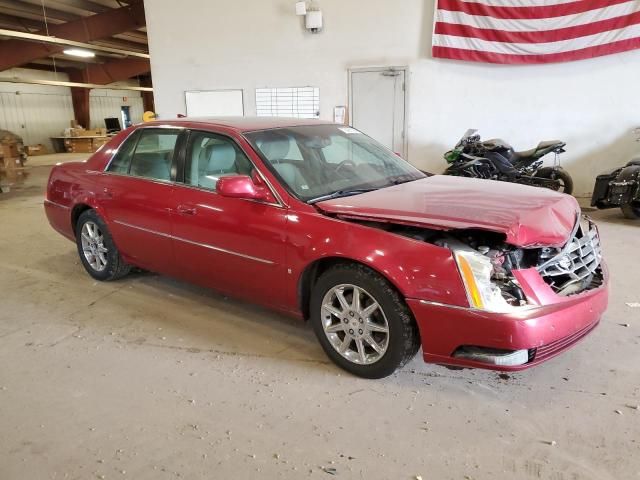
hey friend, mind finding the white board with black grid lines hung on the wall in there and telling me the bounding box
[255,85,320,119]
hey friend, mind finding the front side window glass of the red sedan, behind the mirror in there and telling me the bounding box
[185,132,253,190]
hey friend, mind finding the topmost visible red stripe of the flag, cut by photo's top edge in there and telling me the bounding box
[438,0,635,20]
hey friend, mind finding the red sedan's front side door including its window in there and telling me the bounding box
[173,131,287,307]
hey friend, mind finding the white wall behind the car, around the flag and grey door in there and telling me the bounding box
[145,0,640,196]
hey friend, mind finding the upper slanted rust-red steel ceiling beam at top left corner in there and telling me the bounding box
[0,2,145,71]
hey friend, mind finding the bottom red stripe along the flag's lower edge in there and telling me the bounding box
[433,38,640,64]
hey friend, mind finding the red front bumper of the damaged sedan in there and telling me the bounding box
[407,263,609,371]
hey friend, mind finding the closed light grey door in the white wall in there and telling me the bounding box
[351,68,406,158]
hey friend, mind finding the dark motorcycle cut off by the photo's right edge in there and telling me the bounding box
[591,128,640,219]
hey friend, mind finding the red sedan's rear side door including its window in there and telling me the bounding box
[96,128,183,273]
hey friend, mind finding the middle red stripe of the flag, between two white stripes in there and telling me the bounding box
[435,12,640,43]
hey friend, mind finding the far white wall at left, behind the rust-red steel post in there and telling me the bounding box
[0,68,143,148]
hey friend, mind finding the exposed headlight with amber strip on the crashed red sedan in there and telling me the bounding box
[453,250,516,312]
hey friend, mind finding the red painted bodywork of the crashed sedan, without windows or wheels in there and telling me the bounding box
[45,118,608,370]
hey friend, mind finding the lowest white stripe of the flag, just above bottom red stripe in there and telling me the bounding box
[434,25,640,55]
